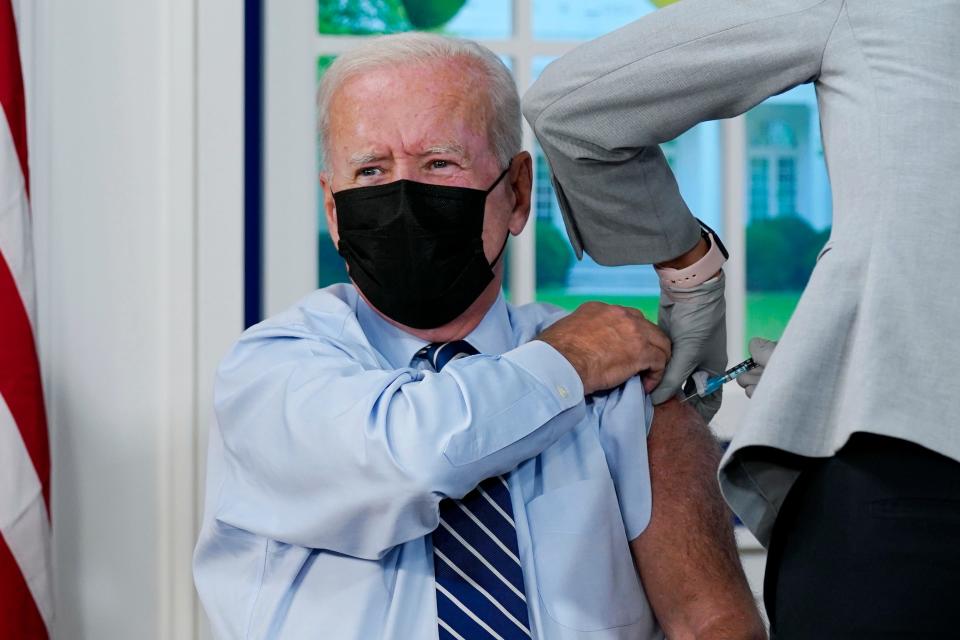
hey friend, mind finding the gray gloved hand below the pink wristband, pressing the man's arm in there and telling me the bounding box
[650,272,727,422]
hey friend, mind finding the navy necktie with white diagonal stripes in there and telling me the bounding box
[418,340,531,640]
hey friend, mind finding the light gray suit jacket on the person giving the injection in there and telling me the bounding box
[524,0,960,543]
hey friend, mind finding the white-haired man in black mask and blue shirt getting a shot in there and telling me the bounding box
[195,35,764,640]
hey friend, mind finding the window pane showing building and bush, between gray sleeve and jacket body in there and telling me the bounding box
[744,85,832,351]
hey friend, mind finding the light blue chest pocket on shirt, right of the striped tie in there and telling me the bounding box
[527,478,648,631]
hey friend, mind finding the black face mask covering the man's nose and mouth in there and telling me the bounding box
[333,164,510,329]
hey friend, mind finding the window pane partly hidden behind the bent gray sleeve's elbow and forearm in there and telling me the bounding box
[533,57,723,319]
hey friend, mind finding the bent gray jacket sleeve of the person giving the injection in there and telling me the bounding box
[523,0,843,265]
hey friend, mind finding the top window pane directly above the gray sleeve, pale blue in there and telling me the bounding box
[533,0,667,40]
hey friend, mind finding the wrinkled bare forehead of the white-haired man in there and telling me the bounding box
[326,60,492,156]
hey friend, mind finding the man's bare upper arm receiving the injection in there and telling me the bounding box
[630,400,766,639]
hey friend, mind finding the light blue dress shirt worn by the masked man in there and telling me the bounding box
[194,285,662,640]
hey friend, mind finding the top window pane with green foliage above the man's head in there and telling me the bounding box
[317,0,512,38]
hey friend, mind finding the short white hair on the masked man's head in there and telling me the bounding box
[317,32,523,166]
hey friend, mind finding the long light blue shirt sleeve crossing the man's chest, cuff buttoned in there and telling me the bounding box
[214,326,584,559]
